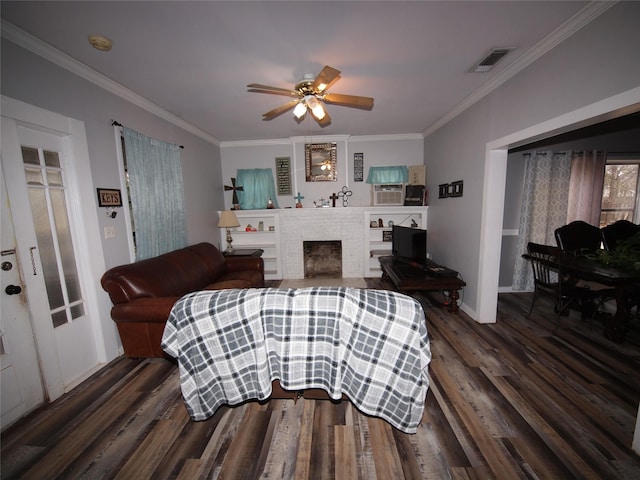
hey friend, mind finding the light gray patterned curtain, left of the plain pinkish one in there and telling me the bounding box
[513,151,571,291]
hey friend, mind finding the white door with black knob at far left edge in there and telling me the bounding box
[0,169,44,430]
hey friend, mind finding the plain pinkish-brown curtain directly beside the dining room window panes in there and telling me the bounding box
[567,150,606,227]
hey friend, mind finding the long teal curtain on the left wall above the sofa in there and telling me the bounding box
[122,127,187,260]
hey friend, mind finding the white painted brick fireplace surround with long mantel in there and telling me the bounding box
[221,206,428,279]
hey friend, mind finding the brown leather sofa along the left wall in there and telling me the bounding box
[101,243,264,358]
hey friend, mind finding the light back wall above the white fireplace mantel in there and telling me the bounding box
[221,134,424,208]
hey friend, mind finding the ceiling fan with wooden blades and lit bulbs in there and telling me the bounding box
[247,65,373,127]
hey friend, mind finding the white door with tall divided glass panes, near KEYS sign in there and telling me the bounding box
[2,117,98,400]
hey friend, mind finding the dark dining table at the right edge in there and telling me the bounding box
[557,253,640,343]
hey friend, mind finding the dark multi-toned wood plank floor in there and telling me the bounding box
[1,281,640,480]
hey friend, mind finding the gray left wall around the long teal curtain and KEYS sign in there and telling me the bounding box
[1,38,223,268]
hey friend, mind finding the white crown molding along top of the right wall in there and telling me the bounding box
[422,0,618,137]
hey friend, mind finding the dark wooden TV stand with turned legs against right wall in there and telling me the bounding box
[379,257,467,313]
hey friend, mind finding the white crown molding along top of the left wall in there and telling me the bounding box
[0,19,220,145]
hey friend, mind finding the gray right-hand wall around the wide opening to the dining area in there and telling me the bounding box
[425,2,640,322]
